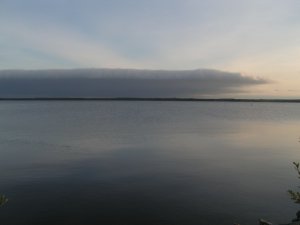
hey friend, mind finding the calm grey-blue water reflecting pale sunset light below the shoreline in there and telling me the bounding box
[0,101,300,225]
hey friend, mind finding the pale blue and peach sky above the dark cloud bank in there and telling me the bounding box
[0,0,300,98]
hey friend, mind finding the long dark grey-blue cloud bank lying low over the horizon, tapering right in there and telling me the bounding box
[0,69,268,98]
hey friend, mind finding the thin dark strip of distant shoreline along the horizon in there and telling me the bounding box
[0,97,300,103]
